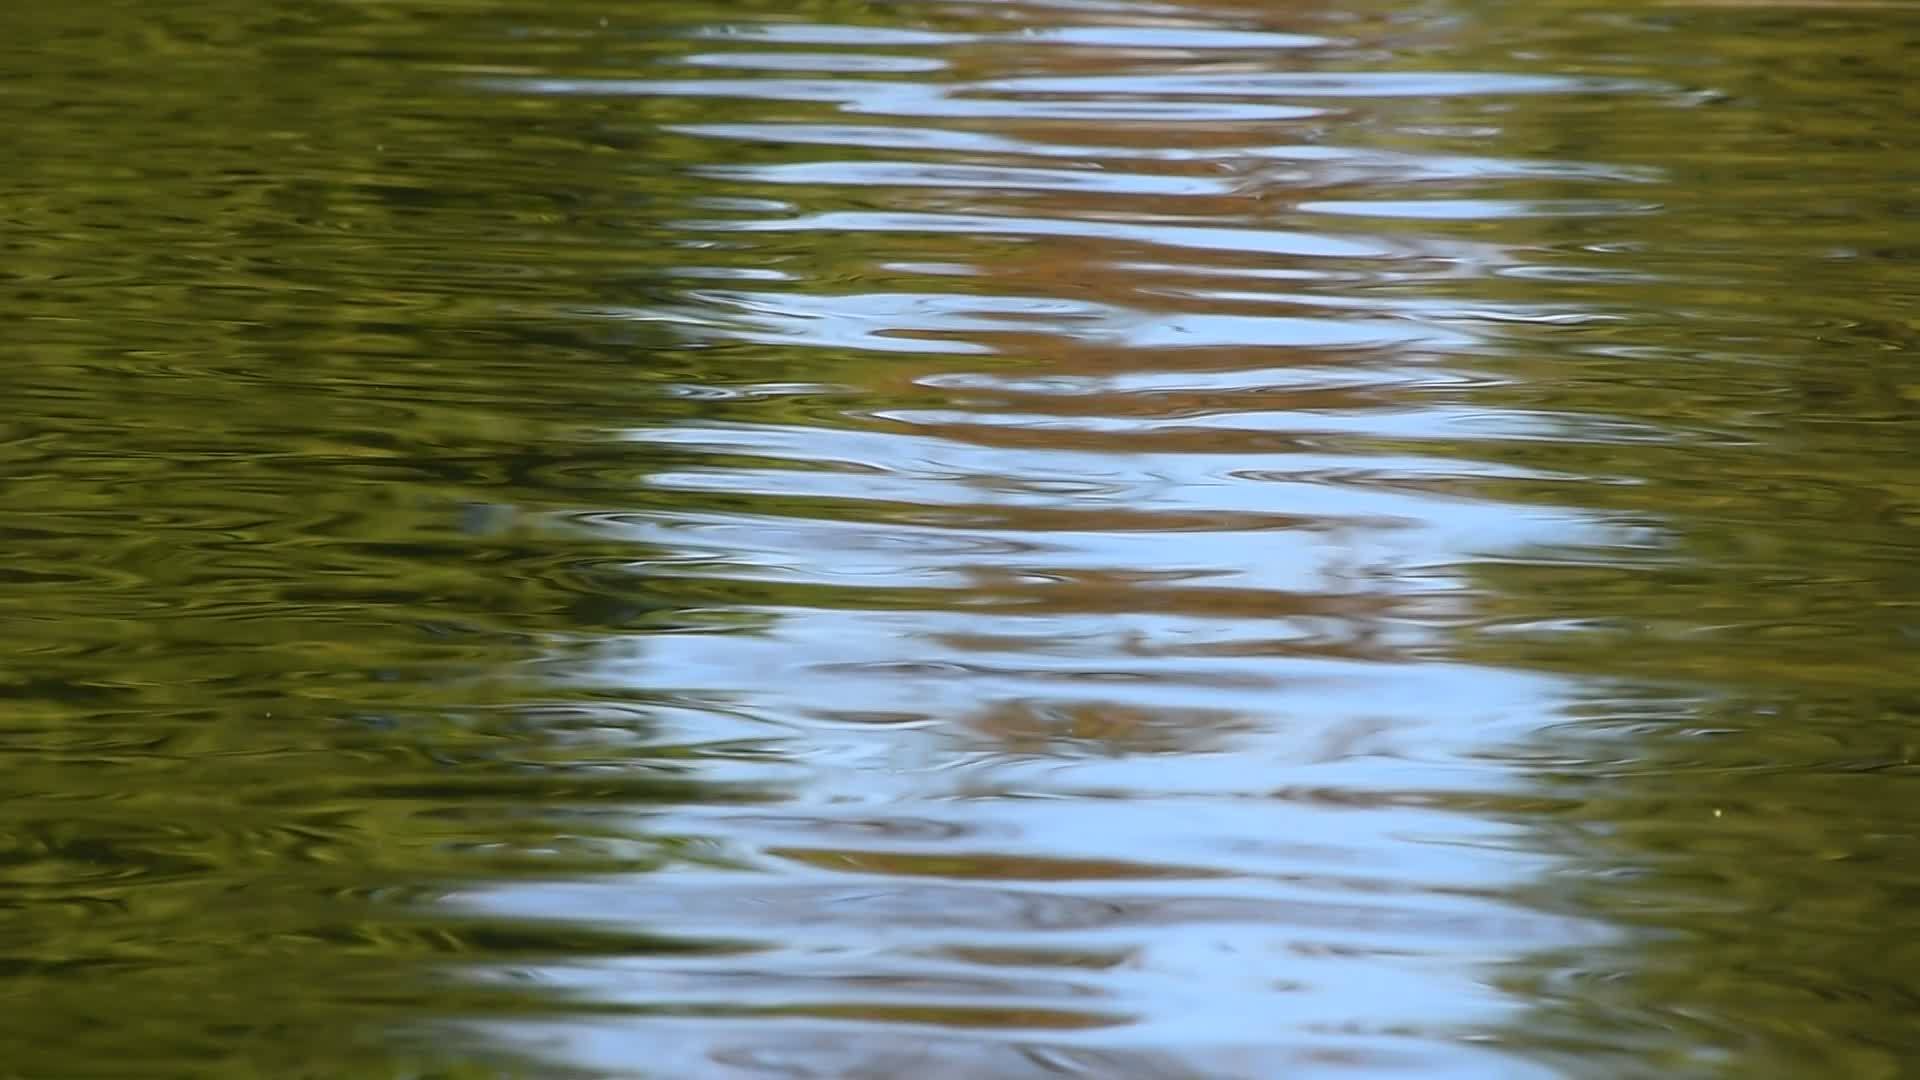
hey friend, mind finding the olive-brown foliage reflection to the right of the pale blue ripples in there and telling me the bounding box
[1390,6,1920,1076]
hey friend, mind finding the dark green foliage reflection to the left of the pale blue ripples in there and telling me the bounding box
[0,0,802,1076]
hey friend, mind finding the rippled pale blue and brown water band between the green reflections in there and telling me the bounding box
[459,6,1655,1076]
